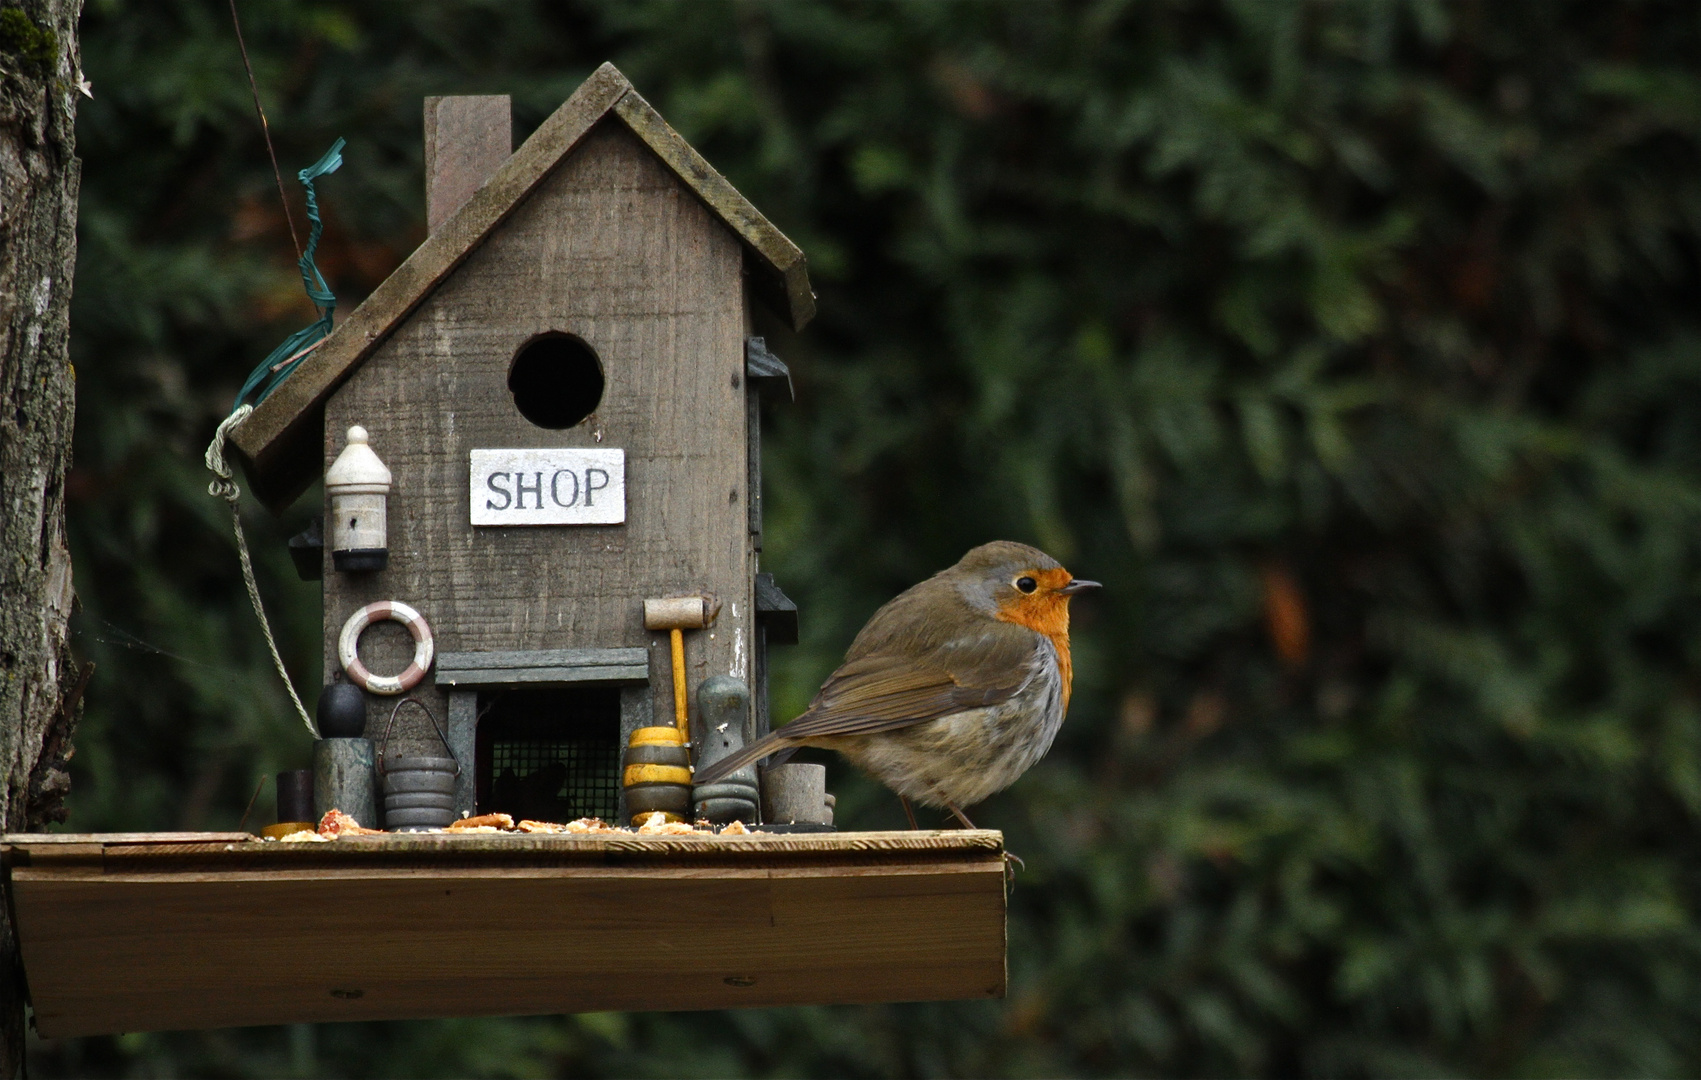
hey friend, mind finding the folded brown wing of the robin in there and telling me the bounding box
[777,619,1044,742]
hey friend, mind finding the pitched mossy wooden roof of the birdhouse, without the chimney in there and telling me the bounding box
[231,63,815,512]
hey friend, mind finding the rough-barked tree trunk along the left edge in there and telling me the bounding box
[0,0,83,1078]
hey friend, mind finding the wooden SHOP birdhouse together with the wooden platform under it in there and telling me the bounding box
[5,65,1005,1036]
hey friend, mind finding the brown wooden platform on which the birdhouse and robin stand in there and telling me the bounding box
[0,830,1005,1037]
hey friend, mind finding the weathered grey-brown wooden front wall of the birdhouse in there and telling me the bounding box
[323,121,754,742]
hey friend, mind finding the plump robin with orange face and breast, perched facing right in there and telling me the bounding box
[696,541,1099,828]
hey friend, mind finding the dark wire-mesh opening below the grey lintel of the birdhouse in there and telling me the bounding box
[478,687,621,821]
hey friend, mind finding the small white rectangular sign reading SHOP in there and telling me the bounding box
[471,447,626,526]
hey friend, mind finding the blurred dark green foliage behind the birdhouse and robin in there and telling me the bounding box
[31,0,1701,1077]
